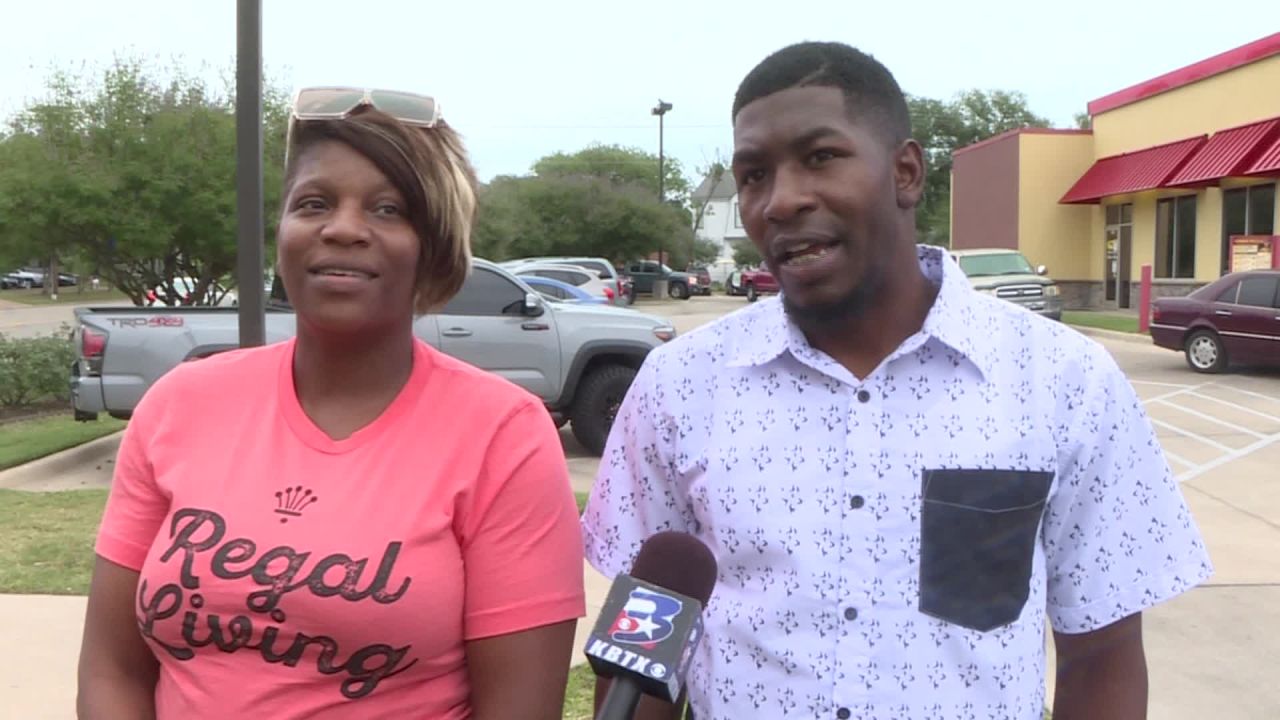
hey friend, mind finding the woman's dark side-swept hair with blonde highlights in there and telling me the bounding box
[284,106,477,314]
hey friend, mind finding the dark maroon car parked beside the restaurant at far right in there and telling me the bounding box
[1151,270,1280,373]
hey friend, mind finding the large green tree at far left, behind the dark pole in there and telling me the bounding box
[0,60,287,304]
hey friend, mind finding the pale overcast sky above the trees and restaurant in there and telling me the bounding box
[0,0,1280,182]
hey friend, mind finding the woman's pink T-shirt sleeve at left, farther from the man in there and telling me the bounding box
[95,382,170,570]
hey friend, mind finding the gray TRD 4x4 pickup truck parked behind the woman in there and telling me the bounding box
[70,260,676,455]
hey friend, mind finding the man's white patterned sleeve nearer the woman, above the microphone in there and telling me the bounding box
[582,351,694,578]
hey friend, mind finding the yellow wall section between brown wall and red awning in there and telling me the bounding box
[1018,133,1093,281]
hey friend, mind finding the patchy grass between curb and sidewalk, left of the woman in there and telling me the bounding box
[0,489,106,594]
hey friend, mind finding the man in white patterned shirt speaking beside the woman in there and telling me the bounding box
[584,44,1211,720]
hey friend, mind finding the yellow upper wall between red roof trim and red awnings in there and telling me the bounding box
[1093,55,1280,157]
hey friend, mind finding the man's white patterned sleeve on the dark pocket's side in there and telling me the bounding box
[1044,348,1212,633]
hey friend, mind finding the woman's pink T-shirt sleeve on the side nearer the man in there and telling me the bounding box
[457,401,586,641]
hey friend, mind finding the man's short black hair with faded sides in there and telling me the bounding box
[732,42,911,145]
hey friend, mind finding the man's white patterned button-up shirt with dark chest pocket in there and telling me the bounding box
[582,247,1211,720]
